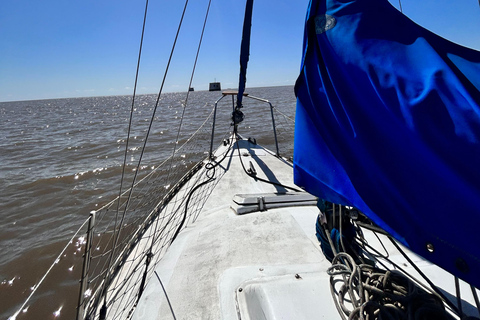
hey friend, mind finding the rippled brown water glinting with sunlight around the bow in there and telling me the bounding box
[0,86,295,319]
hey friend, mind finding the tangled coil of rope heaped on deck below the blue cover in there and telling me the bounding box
[327,252,451,320]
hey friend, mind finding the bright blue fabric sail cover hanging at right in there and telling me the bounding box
[294,0,480,287]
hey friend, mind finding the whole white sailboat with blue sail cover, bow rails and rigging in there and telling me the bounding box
[10,0,480,319]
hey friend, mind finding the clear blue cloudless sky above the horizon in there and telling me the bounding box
[0,0,480,101]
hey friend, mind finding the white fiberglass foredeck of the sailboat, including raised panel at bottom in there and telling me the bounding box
[133,141,475,319]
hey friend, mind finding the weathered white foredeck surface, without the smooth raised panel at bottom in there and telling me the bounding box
[135,141,333,319]
